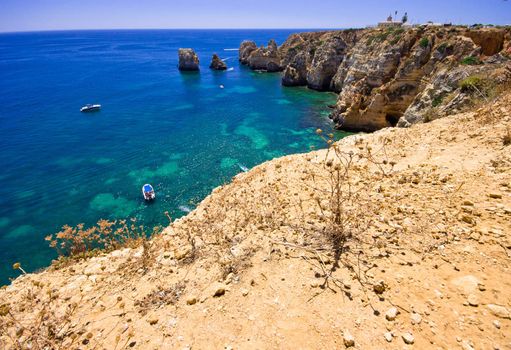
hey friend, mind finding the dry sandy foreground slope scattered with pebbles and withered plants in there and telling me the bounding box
[0,91,511,349]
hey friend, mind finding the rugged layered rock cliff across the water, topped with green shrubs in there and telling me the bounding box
[240,27,511,131]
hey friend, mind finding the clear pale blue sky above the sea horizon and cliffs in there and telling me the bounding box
[0,0,511,32]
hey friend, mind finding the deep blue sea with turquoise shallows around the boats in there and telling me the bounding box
[0,30,343,284]
